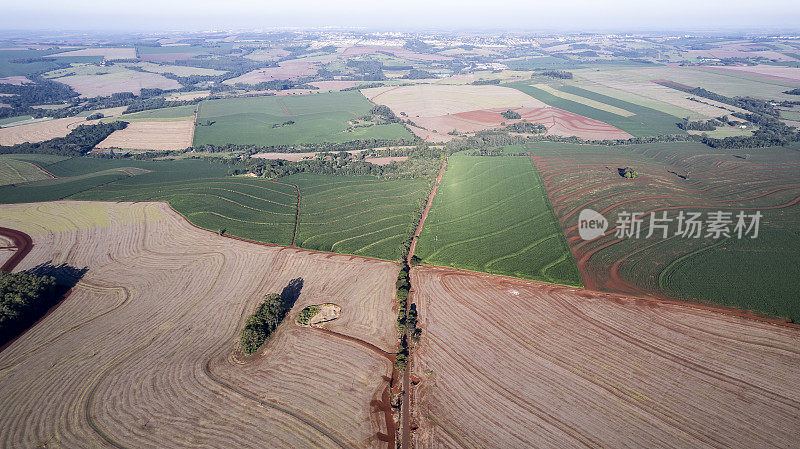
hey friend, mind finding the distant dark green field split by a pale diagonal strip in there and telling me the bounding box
[505,82,685,137]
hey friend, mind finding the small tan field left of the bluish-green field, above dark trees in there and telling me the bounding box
[95,120,194,151]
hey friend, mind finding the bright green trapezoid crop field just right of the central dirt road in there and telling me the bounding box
[416,155,581,285]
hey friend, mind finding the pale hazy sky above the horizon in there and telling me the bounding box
[0,0,800,32]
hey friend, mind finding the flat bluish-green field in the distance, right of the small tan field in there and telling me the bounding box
[194,91,412,146]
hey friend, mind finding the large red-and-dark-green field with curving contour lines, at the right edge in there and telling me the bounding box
[528,143,800,321]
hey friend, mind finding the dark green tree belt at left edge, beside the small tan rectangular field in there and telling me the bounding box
[0,121,128,157]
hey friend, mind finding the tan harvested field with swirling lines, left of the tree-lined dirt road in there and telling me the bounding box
[0,202,397,448]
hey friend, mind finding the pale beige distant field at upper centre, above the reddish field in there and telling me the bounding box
[362,84,547,116]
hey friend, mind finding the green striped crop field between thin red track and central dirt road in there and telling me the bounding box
[292,174,429,260]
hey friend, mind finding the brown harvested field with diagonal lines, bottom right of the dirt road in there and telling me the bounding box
[412,267,800,448]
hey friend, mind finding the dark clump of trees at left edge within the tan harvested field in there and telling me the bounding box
[0,272,56,346]
